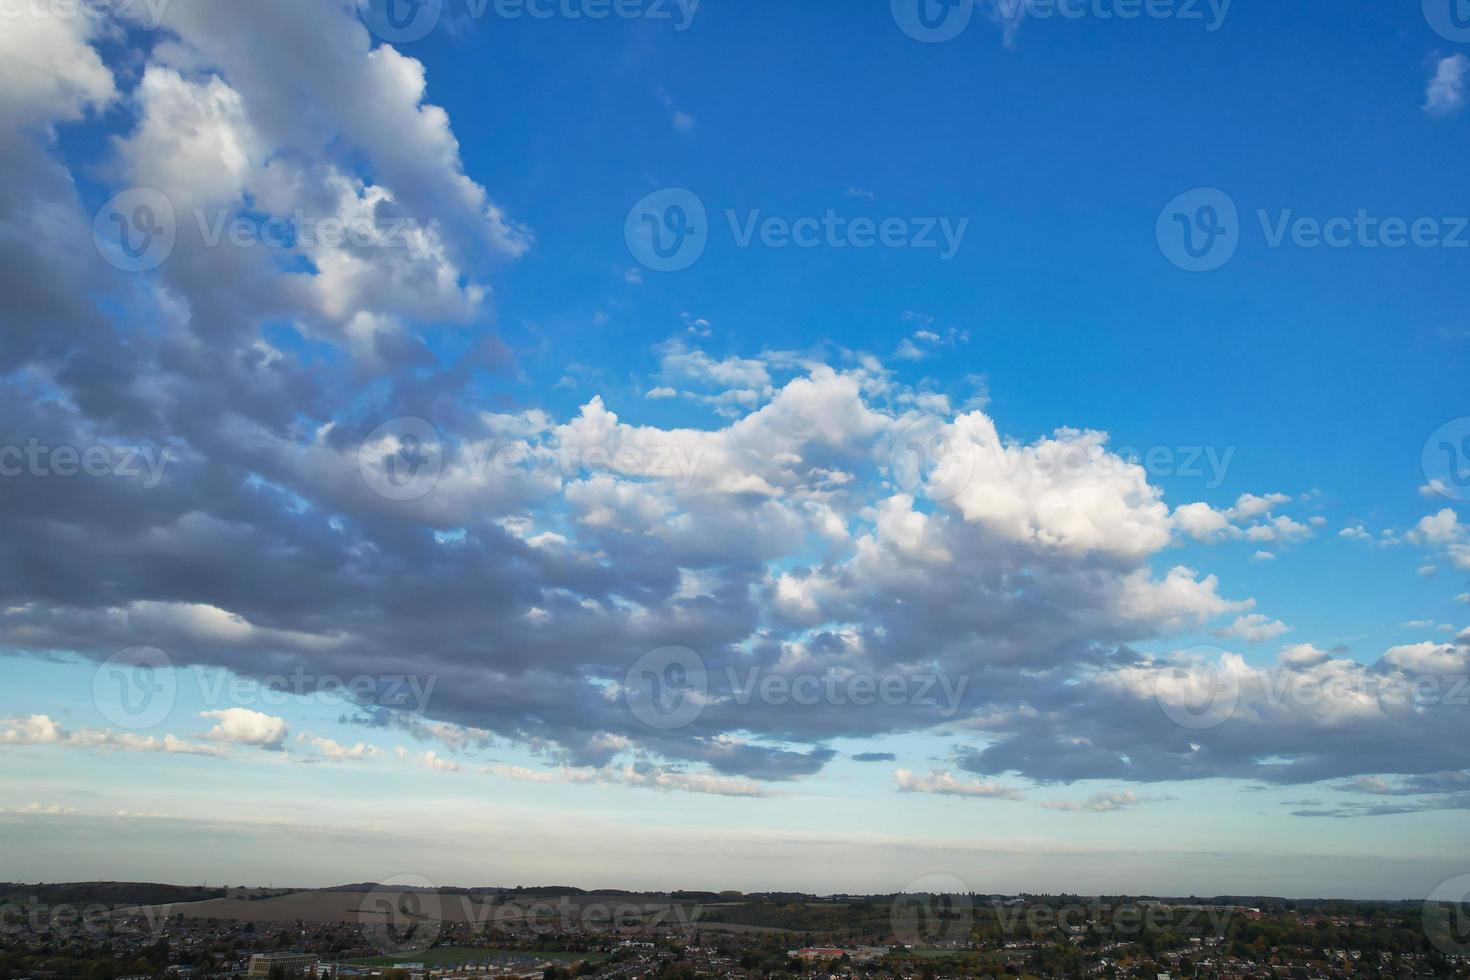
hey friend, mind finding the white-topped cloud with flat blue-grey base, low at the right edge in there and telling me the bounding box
[960,631,1470,783]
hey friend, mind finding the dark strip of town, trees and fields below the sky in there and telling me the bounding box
[0,883,1470,980]
